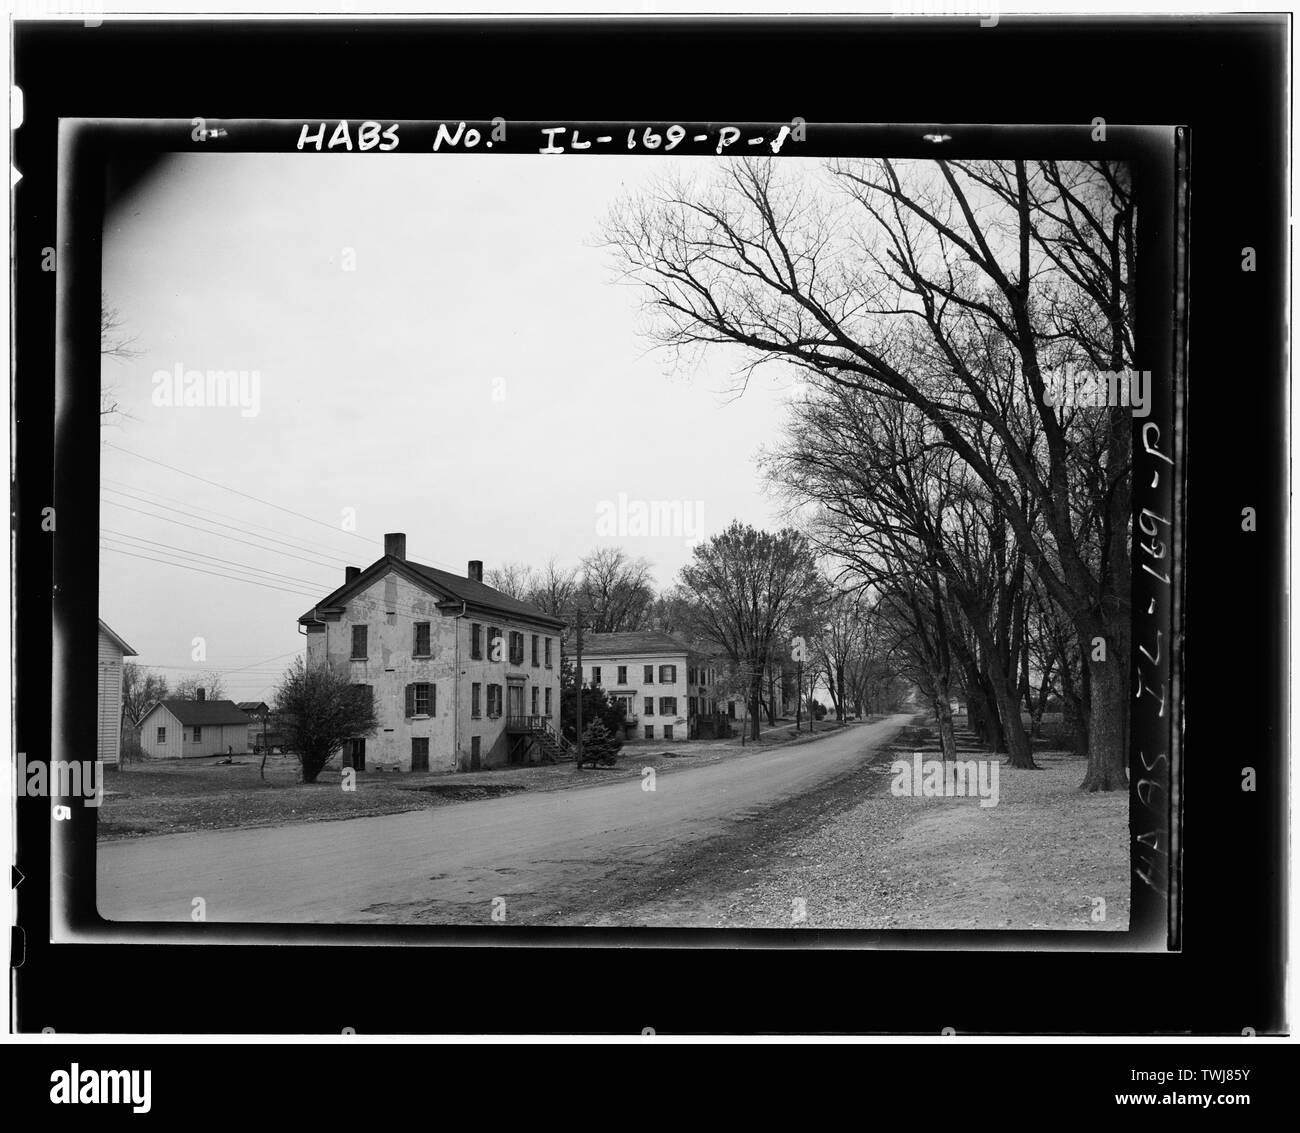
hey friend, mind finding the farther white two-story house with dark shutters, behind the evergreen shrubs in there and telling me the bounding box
[582,630,718,739]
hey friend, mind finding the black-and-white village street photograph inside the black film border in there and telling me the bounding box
[95,135,1173,930]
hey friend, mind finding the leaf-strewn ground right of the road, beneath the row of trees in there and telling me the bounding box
[575,735,1130,930]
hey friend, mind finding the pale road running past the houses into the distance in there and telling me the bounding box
[98,716,907,924]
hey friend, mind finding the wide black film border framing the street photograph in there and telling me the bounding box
[14,13,1286,1033]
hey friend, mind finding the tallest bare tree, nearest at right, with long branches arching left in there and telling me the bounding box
[606,160,1135,790]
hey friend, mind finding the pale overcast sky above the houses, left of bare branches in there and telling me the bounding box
[100,153,811,700]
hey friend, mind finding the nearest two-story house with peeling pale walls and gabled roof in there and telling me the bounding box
[306,533,568,770]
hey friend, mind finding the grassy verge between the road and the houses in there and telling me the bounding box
[98,717,879,841]
